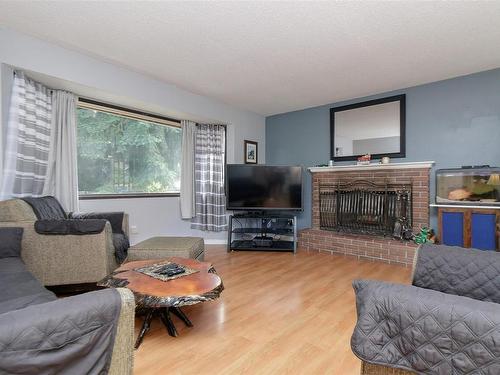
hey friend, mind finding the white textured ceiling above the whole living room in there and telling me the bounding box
[0,1,500,115]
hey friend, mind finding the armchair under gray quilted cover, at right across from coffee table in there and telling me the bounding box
[351,244,500,375]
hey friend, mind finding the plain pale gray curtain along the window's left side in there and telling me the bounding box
[43,91,78,211]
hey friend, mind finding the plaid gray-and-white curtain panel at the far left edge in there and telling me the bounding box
[1,71,52,199]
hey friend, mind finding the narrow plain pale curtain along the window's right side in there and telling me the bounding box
[180,120,196,219]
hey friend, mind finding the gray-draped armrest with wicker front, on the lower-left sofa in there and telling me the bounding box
[0,289,133,374]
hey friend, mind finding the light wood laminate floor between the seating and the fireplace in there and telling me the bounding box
[134,246,410,375]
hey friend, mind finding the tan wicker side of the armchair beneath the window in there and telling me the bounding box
[0,221,118,285]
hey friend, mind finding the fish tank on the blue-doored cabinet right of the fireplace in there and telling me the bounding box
[436,165,500,206]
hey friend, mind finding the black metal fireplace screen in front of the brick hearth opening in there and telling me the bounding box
[319,180,412,236]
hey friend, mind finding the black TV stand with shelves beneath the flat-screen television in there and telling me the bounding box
[227,211,297,253]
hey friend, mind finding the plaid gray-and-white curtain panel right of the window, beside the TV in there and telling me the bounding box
[191,124,227,232]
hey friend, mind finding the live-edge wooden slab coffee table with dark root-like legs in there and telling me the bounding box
[97,257,224,349]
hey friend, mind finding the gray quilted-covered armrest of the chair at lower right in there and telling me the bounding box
[351,280,500,374]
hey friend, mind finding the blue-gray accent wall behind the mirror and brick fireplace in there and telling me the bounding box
[266,69,500,229]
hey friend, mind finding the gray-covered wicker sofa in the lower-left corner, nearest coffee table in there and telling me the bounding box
[0,244,135,375]
